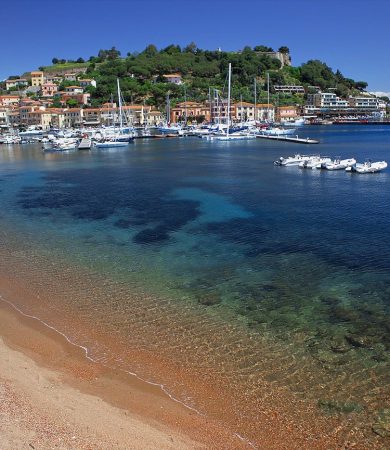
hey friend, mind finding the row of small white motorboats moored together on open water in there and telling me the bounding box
[274,154,387,173]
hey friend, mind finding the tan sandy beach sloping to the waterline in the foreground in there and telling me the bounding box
[0,302,248,449]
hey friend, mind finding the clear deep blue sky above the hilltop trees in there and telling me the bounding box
[0,0,390,92]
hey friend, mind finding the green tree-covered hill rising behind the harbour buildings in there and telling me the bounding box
[45,43,367,107]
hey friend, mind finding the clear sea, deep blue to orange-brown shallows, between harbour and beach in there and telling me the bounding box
[0,125,390,448]
